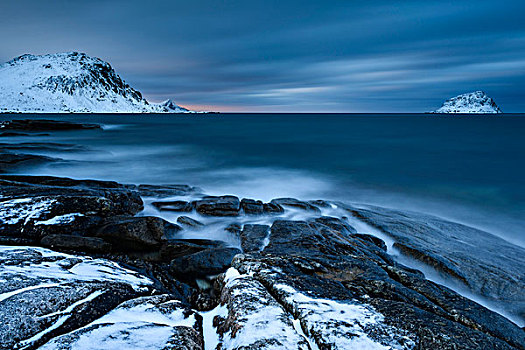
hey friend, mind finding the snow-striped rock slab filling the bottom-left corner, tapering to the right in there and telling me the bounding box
[0,246,153,349]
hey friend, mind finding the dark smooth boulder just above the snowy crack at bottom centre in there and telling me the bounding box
[170,248,241,277]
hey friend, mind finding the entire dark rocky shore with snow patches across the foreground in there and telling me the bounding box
[0,122,525,349]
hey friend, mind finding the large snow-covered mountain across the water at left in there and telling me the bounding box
[0,52,190,113]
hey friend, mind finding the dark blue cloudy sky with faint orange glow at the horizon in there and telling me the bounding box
[0,0,525,112]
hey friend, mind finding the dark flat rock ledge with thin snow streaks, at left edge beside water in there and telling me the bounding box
[0,175,142,243]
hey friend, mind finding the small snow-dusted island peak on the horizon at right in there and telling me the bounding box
[432,91,502,114]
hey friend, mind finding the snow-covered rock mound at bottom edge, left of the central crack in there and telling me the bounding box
[40,295,203,350]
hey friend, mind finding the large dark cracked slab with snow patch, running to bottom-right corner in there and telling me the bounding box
[215,220,525,349]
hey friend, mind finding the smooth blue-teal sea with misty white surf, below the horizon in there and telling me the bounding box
[0,114,525,246]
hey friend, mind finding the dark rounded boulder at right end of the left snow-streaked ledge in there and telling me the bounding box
[95,216,167,251]
